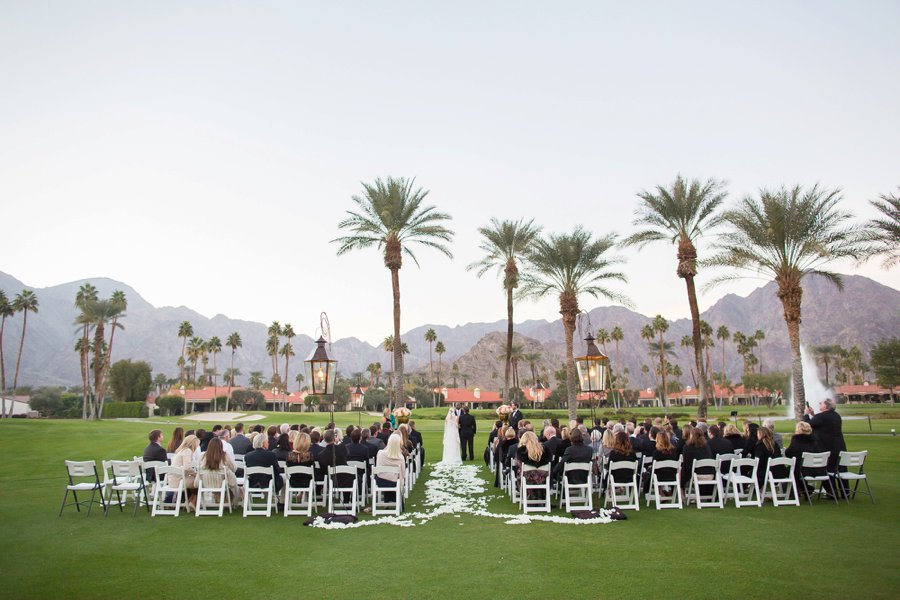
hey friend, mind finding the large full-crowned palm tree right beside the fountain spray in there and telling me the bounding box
[710,185,866,419]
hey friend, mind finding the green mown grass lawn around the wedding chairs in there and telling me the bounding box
[0,414,900,599]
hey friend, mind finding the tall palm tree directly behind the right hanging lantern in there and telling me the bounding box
[523,226,631,419]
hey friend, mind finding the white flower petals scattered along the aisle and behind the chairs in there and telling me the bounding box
[312,463,613,529]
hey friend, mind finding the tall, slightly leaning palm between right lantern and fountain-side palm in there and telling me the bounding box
[623,175,727,418]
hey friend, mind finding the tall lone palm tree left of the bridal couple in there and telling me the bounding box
[333,177,453,404]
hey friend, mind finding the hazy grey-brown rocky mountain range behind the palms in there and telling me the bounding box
[0,272,900,389]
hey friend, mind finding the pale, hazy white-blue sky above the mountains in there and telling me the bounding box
[0,0,900,343]
